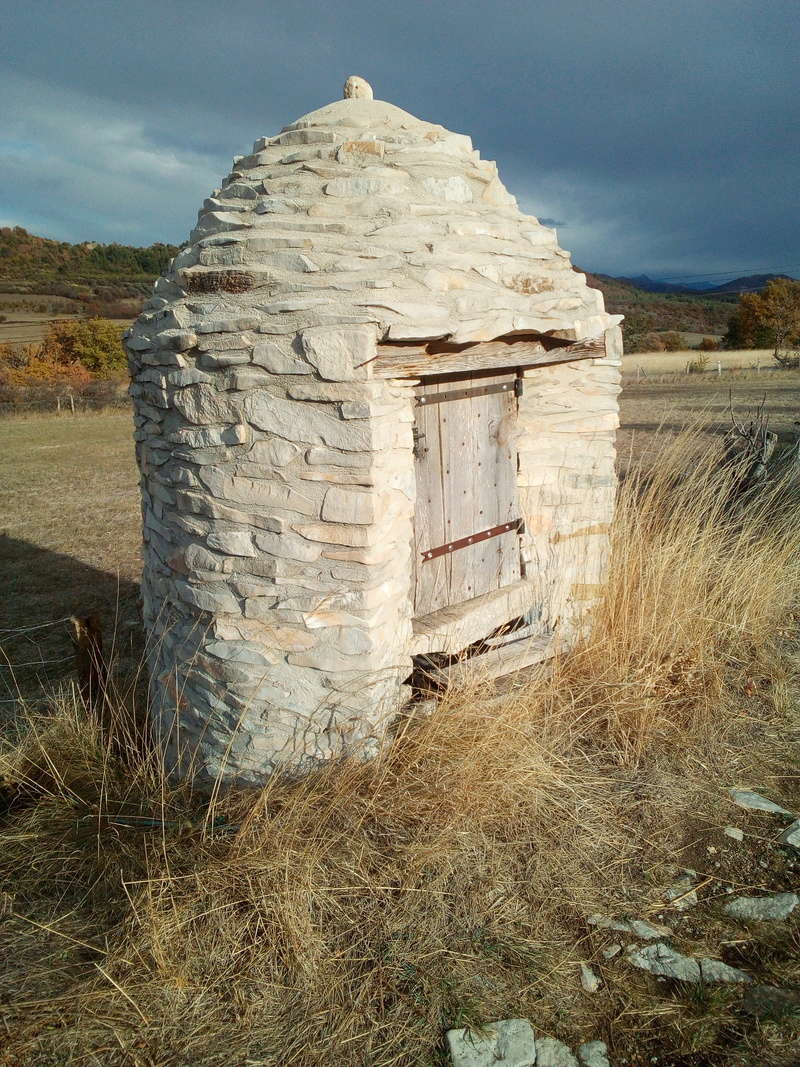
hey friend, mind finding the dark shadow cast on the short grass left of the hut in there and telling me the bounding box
[0,534,143,718]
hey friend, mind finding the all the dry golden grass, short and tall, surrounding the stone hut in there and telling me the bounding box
[0,373,800,1067]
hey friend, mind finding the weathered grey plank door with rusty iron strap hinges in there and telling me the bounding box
[414,371,521,616]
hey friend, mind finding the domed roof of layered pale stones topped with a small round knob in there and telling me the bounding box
[157,79,619,343]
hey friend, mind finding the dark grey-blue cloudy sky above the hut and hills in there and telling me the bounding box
[0,0,800,276]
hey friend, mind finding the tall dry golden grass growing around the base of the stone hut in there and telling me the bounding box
[0,433,800,1067]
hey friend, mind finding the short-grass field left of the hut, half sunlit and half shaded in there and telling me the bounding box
[0,412,141,712]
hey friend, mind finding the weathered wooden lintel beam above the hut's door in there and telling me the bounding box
[367,337,606,378]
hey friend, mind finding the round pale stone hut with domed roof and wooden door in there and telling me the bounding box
[126,78,621,784]
